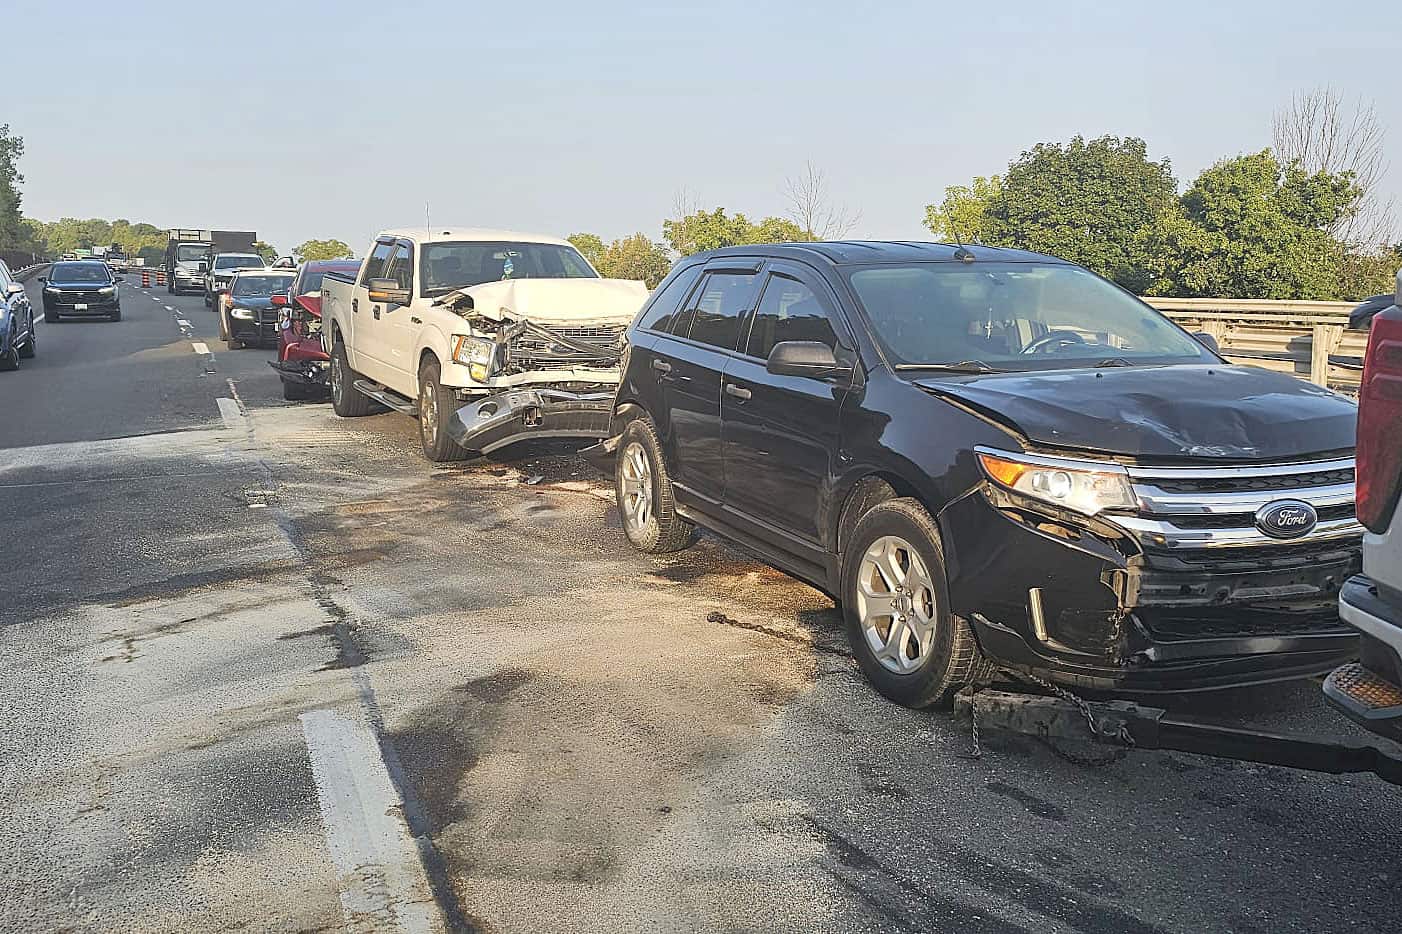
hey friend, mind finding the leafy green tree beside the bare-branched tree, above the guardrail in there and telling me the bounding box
[1143,149,1361,300]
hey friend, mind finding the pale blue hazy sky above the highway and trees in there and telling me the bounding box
[0,0,1402,254]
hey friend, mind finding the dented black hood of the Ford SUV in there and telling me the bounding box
[914,366,1357,461]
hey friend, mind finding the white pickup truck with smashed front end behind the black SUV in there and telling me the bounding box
[321,227,648,461]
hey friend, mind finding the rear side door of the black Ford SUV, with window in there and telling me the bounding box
[651,258,760,510]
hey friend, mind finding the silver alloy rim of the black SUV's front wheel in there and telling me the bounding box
[857,536,938,675]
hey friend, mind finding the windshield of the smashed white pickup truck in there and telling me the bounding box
[421,241,599,296]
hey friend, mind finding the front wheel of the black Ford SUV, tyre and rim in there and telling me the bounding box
[843,498,987,707]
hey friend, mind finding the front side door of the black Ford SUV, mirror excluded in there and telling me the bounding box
[721,262,855,547]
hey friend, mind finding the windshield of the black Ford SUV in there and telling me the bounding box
[847,262,1216,370]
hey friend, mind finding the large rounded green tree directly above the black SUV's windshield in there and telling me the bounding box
[984,136,1178,290]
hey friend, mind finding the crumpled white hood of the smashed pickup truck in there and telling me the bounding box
[437,279,648,325]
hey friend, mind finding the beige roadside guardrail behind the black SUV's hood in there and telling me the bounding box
[1144,297,1368,395]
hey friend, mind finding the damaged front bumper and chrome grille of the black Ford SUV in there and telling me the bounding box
[939,457,1363,693]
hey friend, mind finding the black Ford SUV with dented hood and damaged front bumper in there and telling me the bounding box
[594,243,1361,705]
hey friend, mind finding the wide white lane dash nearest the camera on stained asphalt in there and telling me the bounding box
[301,710,440,934]
